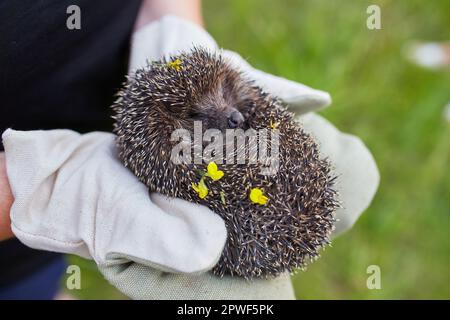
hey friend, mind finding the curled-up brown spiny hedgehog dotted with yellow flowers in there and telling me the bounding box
[112,48,339,279]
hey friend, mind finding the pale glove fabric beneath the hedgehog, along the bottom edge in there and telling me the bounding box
[99,257,295,300]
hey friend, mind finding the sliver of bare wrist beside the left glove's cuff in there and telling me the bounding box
[0,152,13,241]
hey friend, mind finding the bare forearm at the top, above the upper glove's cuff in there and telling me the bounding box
[134,0,203,30]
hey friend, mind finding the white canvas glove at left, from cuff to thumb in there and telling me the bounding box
[2,129,226,273]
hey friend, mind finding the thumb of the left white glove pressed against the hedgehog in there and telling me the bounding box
[101,173,227,273]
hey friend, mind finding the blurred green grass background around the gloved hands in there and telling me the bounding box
[65,0,450,299]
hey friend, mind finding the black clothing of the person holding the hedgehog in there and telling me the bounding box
[0,0,140,286]
